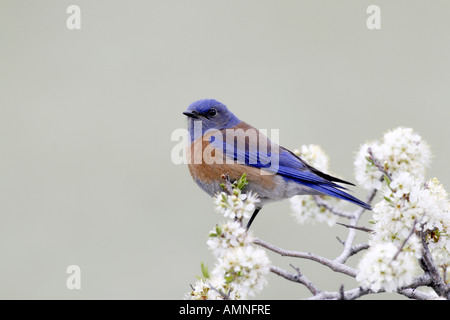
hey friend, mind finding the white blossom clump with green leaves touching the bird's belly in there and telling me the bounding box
[214,188,260,220]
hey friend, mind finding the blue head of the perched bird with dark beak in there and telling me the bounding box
[183,99,240,132]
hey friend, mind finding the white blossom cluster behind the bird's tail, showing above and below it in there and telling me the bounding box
[289,144,343,227]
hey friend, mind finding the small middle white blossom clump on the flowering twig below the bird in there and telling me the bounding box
[207,221,253,257]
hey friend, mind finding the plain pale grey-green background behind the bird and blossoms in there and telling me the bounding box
[0,0,450,299]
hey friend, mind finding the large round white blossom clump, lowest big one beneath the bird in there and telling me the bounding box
[212,246,270,296]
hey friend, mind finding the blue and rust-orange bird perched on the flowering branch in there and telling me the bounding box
[183,99,372,229]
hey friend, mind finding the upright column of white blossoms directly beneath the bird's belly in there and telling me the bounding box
[186,180,270,300]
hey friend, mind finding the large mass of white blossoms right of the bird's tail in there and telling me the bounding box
[355,128,450,292]
